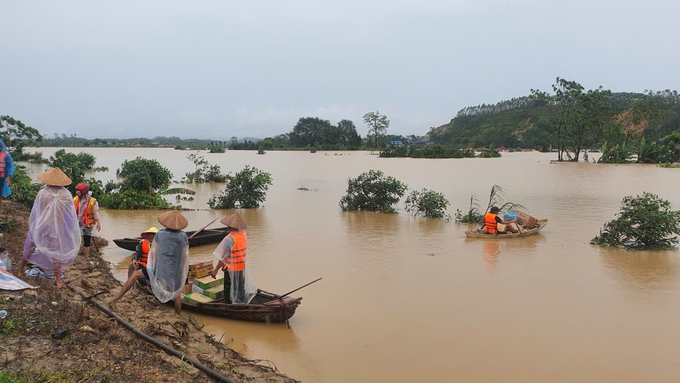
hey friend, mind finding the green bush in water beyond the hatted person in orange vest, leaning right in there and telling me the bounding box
[208,166,272,209]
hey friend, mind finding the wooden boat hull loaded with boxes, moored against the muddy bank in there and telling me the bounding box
[182,290,302,323]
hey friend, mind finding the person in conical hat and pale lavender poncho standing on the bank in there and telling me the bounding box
[19,168,80,287]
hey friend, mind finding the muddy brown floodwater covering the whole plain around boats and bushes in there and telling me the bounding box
[23,148,680,382]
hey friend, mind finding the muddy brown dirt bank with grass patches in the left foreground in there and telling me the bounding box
[0,201,296,383]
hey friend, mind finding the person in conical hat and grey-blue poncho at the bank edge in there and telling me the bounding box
[146,210,189,314]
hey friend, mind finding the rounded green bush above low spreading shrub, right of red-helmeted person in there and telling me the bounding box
[116,157,172,194]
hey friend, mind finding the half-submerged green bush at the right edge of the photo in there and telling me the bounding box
[590,192,680,250]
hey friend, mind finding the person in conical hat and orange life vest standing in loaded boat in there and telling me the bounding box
[210,213,257,304]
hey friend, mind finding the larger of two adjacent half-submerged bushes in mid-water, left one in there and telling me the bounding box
[340,170,407,213]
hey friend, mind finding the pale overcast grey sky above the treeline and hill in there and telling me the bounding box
[0,0,680,139]
